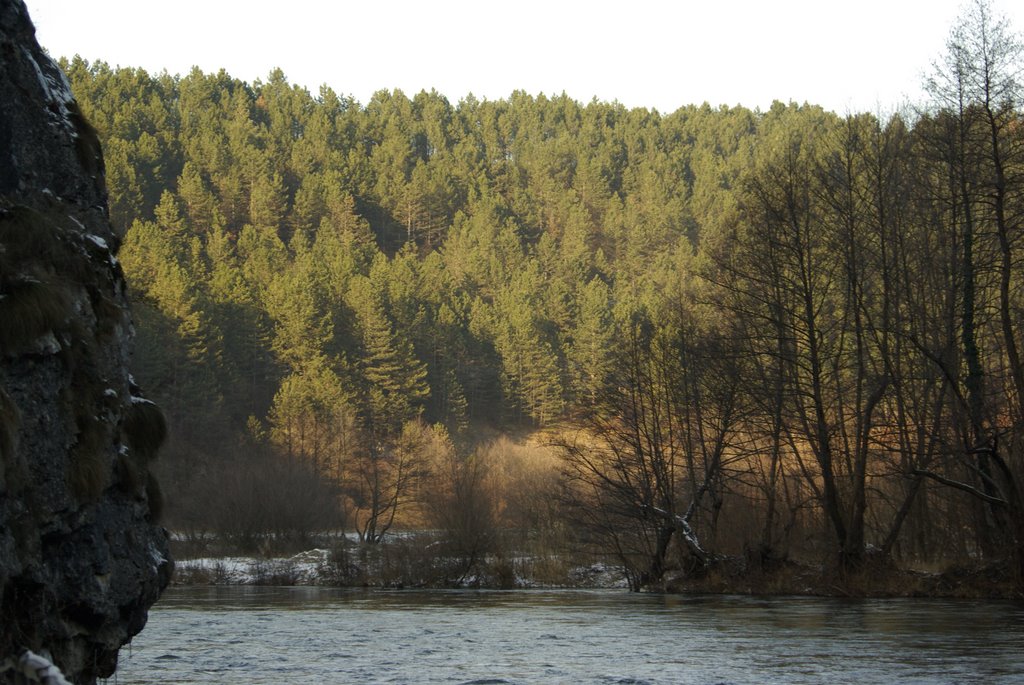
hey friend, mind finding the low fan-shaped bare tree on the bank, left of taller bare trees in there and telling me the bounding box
[560,305,738,590]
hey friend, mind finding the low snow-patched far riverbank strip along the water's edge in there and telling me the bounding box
[172,548,1024,600]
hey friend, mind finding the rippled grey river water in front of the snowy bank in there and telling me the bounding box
[111,587,1024,685]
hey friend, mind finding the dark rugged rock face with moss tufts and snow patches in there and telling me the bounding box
[0,0,172,683]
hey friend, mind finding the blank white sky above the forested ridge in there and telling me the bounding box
[27,0,1024,113]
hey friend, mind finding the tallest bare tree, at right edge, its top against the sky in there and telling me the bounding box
[922,0,1024,576]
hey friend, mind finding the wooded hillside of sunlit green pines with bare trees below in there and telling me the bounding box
[56,3,1024,589]
